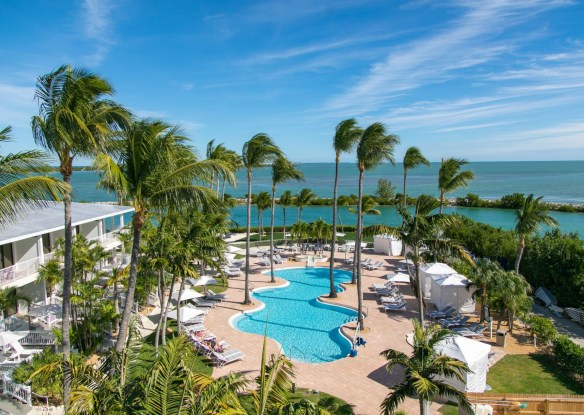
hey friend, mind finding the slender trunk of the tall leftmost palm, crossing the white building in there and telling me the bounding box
[61,174,73,410]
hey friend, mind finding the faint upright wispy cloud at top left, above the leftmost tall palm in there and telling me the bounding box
[82,0,114,66]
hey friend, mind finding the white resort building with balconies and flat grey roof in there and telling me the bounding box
[0,203,134,314]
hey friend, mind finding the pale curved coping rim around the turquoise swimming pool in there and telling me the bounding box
[227,267,358,365]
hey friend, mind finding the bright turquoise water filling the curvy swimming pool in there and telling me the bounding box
[233,268,357,363]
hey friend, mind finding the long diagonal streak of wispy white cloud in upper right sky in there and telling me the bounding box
[327,0,571,114]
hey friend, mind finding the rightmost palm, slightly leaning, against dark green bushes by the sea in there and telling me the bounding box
[515,193,558,274]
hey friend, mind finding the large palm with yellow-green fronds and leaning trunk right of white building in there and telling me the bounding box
[95,120,230,352]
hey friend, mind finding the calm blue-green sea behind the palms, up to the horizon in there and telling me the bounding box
[66,161,584,235]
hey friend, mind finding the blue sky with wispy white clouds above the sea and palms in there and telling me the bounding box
[0,0,584,162]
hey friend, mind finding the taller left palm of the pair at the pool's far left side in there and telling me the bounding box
[241,133,282,304]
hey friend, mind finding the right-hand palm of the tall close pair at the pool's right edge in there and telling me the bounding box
[355,123,399,329]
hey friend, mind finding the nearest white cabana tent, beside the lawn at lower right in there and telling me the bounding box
[436,336,491,393]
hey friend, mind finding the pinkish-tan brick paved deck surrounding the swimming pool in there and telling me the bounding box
[205,253,440,415]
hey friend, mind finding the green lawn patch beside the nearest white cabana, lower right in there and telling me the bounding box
[487,354,584,394]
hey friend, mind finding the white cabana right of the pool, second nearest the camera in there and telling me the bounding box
[430,274,475,313]
